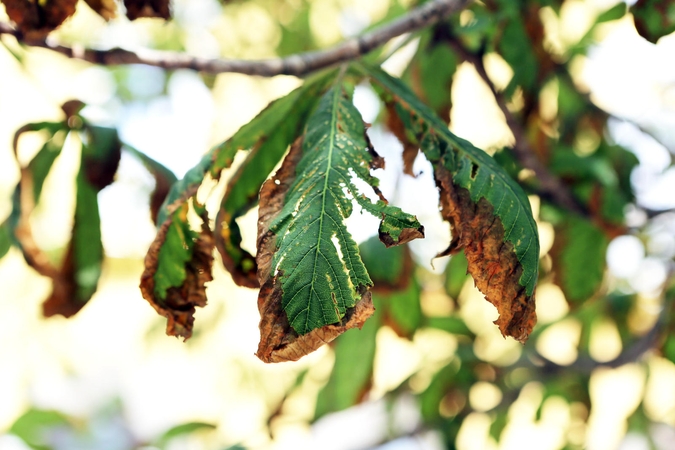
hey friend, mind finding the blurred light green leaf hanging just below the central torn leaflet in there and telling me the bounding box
[314,315,380,419]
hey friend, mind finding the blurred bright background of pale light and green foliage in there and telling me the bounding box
[0,0,675,449]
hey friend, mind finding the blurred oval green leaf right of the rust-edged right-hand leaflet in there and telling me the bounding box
[552,216,609,304]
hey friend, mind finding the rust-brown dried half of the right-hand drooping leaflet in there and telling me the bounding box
[435,165,537,343]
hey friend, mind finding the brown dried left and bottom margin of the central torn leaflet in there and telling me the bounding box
[256,139,375,363]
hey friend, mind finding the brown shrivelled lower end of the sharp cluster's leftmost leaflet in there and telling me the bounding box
[140,202,214,340]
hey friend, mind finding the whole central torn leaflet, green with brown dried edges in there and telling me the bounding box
[257,82,424,362]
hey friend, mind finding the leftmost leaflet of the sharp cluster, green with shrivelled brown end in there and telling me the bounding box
[140,71,336,339]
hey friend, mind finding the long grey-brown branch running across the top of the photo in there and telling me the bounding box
[0,0,469,77]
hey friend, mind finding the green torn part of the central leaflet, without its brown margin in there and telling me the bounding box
[261,85,422,335]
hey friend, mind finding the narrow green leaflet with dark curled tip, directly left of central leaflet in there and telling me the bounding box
[215,72,334,288]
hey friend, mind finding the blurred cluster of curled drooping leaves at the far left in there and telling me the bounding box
[0,101,176,317]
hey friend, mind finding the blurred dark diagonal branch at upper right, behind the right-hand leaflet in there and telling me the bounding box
[449,37,587,215]
